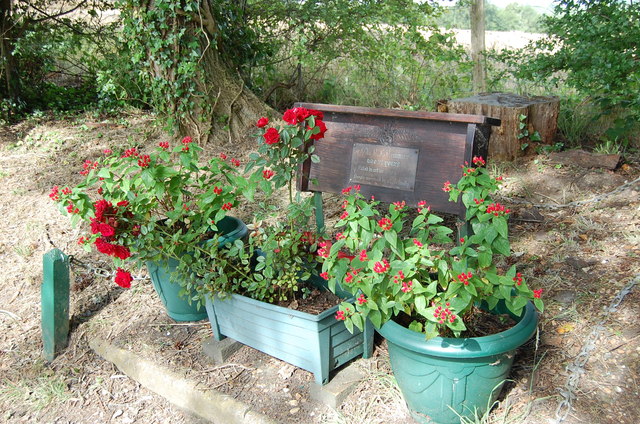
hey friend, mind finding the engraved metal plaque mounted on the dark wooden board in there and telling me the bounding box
[349,143,418,191]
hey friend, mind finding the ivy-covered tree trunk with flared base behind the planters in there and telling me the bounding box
[136,0,273,144]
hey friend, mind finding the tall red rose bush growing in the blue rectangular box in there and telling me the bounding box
[197,108,327,303]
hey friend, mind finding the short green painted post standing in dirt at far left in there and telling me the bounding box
[40,249,69,361]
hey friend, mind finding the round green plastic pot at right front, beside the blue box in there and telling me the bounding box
[379,302,538,424]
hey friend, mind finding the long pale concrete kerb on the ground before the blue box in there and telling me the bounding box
[89,338,276,424]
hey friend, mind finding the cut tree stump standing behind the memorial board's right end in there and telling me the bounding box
[446,93,560,160]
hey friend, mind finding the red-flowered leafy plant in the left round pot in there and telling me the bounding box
[49,137,250,288]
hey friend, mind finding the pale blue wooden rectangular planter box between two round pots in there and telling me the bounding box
[206,277,374,384]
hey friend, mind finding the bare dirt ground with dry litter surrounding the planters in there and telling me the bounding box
[0,113,640,424]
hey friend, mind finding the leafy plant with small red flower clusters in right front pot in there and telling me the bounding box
[318,157,544,338]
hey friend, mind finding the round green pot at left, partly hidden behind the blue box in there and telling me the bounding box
[147,216,248,321]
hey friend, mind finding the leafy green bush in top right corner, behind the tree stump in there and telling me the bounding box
[503,0,640,143]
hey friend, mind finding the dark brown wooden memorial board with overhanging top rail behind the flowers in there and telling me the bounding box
[295,103,500,216]
